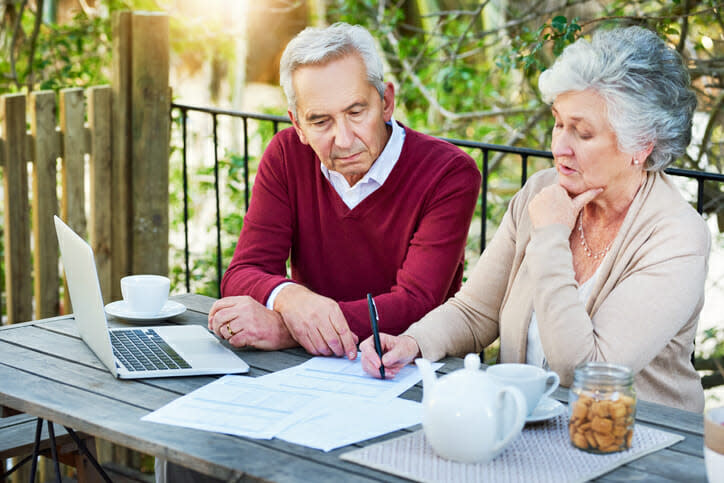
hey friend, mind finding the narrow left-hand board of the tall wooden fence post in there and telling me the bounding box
[110,11,131,300]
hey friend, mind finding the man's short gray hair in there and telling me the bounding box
[279,22,385,118]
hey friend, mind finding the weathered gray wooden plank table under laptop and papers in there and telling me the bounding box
[0,295,706,482]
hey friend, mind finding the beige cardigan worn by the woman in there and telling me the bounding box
[405,169,711,412]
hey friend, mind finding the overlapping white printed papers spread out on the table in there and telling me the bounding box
[142,357,442,451]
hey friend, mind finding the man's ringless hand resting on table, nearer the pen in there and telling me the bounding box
[274,284,358,360]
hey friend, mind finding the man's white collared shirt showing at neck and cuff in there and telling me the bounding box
[266,117,405,310]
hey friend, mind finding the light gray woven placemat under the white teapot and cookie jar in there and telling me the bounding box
[340,414,684,483]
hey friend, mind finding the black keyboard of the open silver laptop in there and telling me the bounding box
[110,329,191,371]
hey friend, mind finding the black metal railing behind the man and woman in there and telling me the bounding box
[171,103,724,292]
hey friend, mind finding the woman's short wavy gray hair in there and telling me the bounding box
[538,27,696,171]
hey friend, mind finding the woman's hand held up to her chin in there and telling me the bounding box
[528,184,603,230]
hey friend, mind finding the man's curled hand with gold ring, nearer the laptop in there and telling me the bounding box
[209,296,297,350]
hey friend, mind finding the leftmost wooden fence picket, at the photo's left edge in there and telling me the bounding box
[0,94,33,324]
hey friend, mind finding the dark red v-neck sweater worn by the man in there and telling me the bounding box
[221,123,481,340]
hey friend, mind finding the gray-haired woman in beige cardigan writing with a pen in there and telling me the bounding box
[361,27,710,412]
